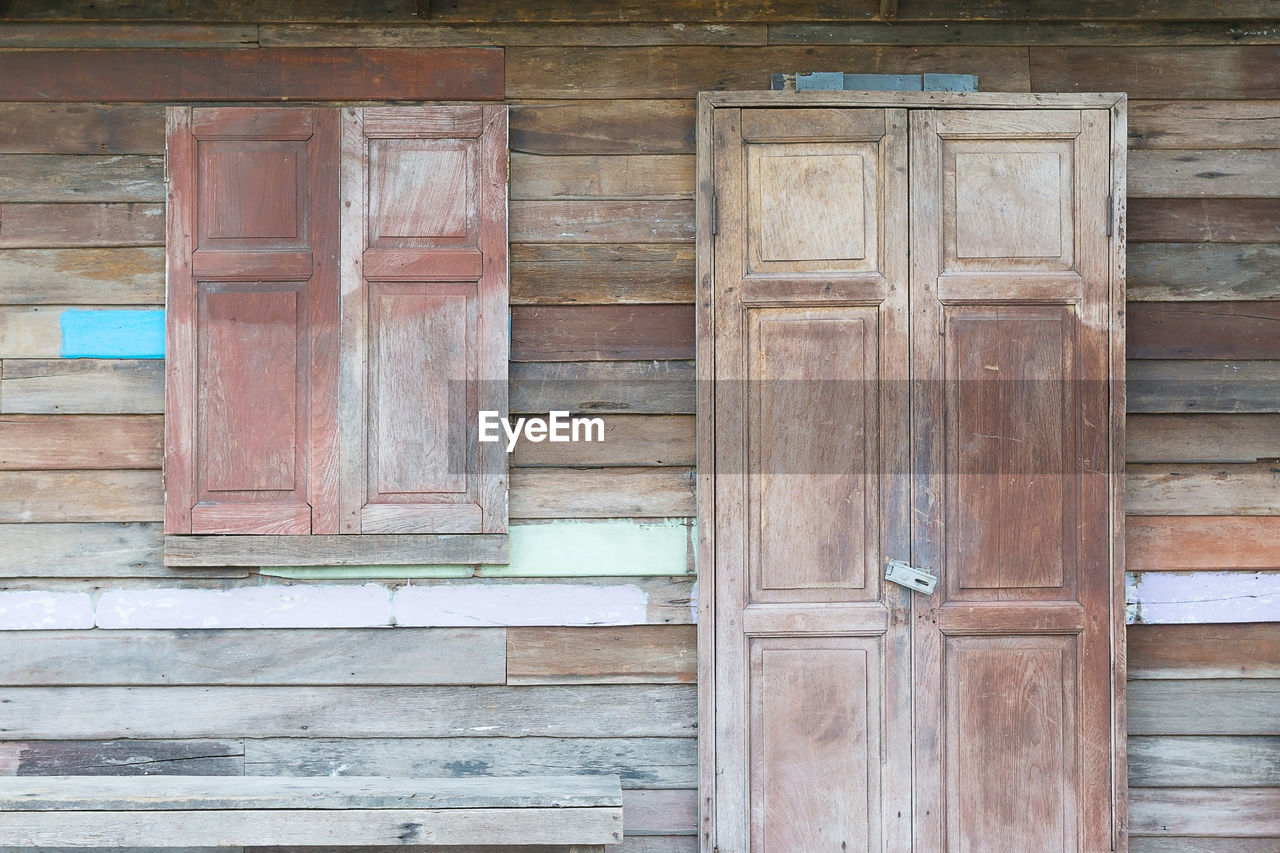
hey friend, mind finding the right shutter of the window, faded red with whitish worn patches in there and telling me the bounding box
[339,106,508,533]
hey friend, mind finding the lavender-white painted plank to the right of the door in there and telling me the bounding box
[1125,571,1280,624]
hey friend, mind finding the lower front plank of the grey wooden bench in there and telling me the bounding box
[0,799,622,848]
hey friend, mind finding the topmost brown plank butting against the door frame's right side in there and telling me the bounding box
[1131,100,1280,149]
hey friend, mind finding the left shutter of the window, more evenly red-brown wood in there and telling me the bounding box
[165,108,338,534]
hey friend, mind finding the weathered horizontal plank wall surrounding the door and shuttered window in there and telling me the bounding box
[0,0,1280,853]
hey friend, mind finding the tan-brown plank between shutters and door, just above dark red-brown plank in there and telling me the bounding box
[509,243,694,305]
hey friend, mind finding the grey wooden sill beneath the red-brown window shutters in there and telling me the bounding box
[164,533,511,567]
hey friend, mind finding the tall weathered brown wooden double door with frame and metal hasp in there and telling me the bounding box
[699,96,1124,853]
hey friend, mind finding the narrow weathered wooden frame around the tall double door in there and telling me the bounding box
[695,91,1128,853]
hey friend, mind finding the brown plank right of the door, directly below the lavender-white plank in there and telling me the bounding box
[1128,622,1280,679]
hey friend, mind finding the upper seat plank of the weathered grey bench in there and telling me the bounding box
[0,776,622,812]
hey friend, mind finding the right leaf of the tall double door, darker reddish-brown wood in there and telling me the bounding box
[911,110,1111,853]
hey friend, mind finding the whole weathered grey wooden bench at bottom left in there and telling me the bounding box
[0,776,622,853]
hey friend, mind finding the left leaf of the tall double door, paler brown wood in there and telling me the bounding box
[714,110,910,853]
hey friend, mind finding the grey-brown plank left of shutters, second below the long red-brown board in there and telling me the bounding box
[0,154,164,202]
